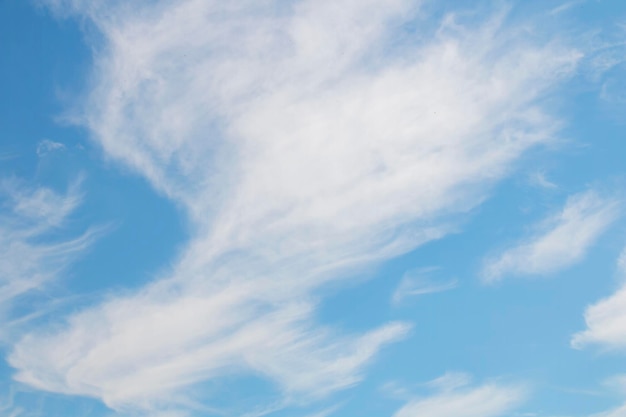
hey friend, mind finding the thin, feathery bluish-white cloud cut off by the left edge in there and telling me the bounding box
[0,179,95,334]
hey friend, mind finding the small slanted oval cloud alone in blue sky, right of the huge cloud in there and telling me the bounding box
[482,190,620,282]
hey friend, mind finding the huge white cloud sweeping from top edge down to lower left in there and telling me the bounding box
[10,0,580,410]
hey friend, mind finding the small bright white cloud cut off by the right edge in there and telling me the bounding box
[572,245,626,352]
